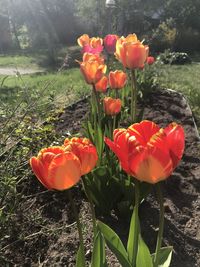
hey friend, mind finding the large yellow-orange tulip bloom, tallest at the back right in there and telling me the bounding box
[115,34,149,69]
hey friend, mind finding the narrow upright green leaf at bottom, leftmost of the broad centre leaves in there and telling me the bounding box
[91,231,106,267]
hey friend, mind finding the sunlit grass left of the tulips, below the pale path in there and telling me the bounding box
[0,68,90,118]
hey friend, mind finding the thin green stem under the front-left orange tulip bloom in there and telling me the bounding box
[67,190,86,267]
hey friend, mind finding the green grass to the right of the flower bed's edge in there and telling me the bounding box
[158,63,200,126]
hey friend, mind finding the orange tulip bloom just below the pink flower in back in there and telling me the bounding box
[78,53,107,84]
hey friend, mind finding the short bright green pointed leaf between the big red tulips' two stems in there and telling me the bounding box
[136,234,153,267]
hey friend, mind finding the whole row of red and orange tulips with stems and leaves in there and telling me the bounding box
[30,34,185,267]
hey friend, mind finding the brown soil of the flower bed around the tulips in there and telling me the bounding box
[0,90,200,267]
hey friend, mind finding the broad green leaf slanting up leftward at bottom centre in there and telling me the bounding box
[97,221,131,267]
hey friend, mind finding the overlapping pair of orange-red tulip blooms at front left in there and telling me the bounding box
[30,138,97,190]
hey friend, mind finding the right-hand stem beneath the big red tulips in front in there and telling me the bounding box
[154,183,164,267]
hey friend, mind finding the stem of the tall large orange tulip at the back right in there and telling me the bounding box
[131,70,137,123]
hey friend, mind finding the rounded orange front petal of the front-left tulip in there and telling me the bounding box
[48,152,81,190]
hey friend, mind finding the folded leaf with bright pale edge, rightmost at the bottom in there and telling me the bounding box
[151,247,173,267]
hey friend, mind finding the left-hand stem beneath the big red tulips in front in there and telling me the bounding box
[132,180,140,267]
